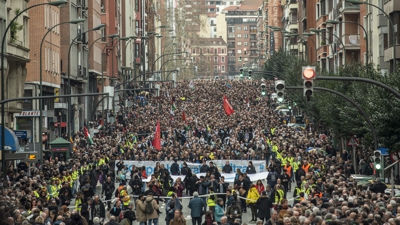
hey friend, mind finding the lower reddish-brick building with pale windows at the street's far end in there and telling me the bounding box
[190,37,228,79]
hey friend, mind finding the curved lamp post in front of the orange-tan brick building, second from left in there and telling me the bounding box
[39,19,85,160]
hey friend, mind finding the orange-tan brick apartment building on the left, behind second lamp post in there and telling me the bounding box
[21,0,61,142]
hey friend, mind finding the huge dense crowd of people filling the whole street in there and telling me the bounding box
[0,80,400,225]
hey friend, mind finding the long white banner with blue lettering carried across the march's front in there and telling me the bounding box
[119,160,268,183]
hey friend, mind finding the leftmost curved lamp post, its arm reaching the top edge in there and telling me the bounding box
[1,0,68,179]
